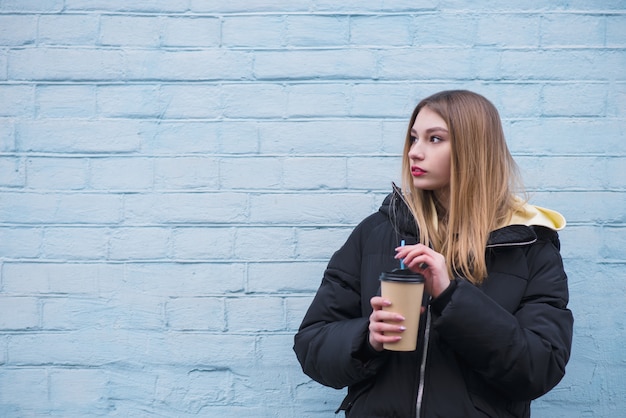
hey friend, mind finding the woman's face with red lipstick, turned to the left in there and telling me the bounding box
[408,107,450,203]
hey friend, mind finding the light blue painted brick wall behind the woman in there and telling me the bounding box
[0,0,626,418]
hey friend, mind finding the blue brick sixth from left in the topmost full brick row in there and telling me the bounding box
[285,14,350,48]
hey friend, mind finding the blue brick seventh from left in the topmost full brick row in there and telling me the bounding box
[350,15,412,48]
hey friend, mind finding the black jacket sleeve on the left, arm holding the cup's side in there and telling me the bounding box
[294,217,384,389]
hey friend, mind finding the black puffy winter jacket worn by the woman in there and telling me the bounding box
[294,193,573,418]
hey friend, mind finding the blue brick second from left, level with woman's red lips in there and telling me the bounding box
[26,157,89,190]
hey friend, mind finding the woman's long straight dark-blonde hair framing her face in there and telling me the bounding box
[402,90,522,284]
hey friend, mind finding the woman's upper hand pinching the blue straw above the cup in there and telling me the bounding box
[395,244,450,298]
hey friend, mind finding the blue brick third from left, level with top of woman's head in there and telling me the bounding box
[97,85,164,118]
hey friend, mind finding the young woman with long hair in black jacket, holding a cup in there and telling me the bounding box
[294,90,573,418]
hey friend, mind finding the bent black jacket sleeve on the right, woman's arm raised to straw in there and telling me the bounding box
[434,232,574,400]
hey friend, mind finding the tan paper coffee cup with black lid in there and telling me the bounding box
[380,269,424,351]
